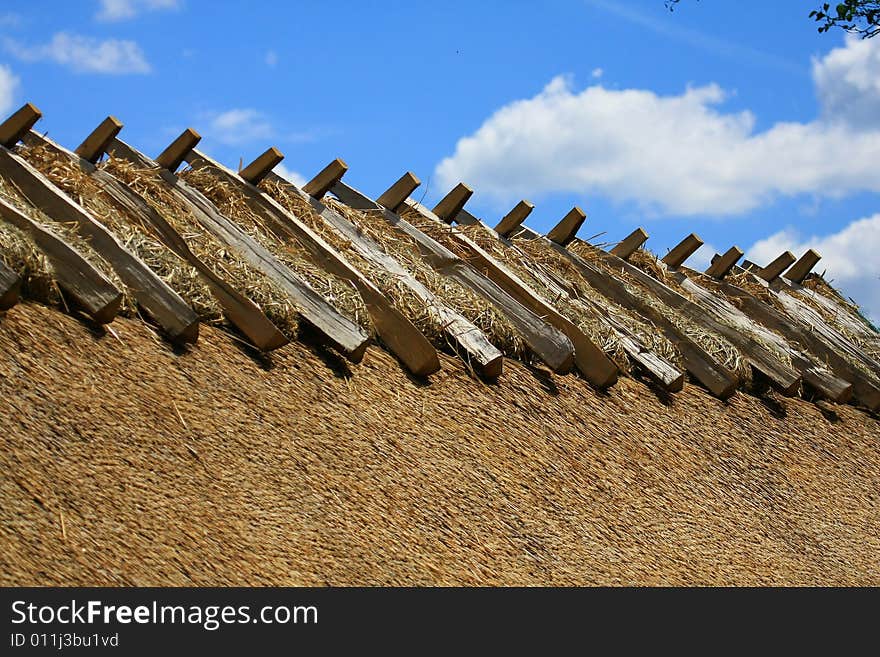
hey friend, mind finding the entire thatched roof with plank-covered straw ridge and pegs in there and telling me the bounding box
[0,105,880,585]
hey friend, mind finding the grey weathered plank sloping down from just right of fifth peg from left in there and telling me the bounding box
[330,181,574,373]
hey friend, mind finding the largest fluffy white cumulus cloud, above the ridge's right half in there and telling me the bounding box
[436,39,880,215]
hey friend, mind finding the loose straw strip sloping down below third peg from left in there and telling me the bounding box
[180,169,372,331]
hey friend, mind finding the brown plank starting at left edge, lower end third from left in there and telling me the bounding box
[0,147,199,342]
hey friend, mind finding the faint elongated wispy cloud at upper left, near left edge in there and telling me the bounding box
[3,32,150,75]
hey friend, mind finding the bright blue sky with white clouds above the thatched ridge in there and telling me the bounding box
[0,0,880,318]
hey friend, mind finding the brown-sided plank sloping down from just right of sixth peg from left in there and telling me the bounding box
[407,200,618,388]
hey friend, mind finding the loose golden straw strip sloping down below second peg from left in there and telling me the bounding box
[101,157,299,336]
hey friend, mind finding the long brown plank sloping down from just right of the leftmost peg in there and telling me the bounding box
[23,130,289,351]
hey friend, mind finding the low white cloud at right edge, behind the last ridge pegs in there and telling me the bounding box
[746,213,880,324]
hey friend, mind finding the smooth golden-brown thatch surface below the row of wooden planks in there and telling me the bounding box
[0,303,880,585]
